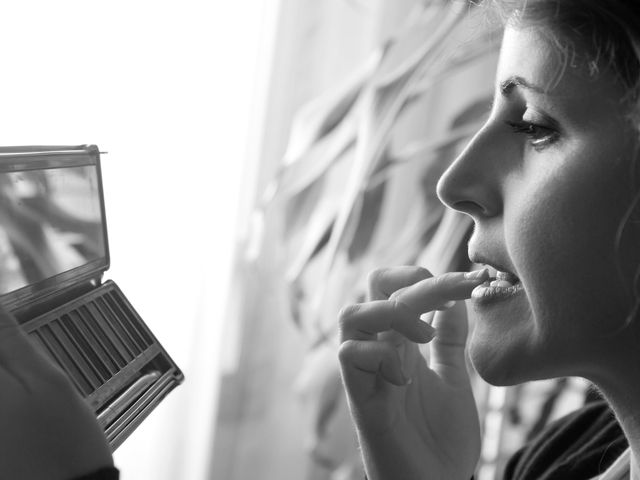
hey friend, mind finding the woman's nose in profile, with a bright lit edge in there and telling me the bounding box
[437,125,506,220]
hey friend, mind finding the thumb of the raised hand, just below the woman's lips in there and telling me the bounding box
[430,301,469,386]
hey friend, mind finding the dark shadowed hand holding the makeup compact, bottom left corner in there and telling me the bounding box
[0,306,113,480]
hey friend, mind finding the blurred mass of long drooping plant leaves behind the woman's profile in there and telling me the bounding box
[258,0,499,341]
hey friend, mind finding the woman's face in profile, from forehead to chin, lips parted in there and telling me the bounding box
[438,28,636,384]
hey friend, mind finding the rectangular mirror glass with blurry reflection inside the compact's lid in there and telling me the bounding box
[0,165,105,294]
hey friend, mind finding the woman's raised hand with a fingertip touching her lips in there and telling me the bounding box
[340,267,488,480]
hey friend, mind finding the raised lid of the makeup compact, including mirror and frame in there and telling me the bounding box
[0,145,109,310]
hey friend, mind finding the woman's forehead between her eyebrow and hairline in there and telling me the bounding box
[497,27,625,106]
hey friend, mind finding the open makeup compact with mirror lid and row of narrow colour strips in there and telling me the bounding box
[0,145,184,450]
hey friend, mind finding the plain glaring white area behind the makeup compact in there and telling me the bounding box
[0,0,277,480]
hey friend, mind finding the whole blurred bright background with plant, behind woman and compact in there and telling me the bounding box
[0,0,585,480]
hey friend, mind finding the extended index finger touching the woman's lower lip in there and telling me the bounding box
[389,268,489,314]
